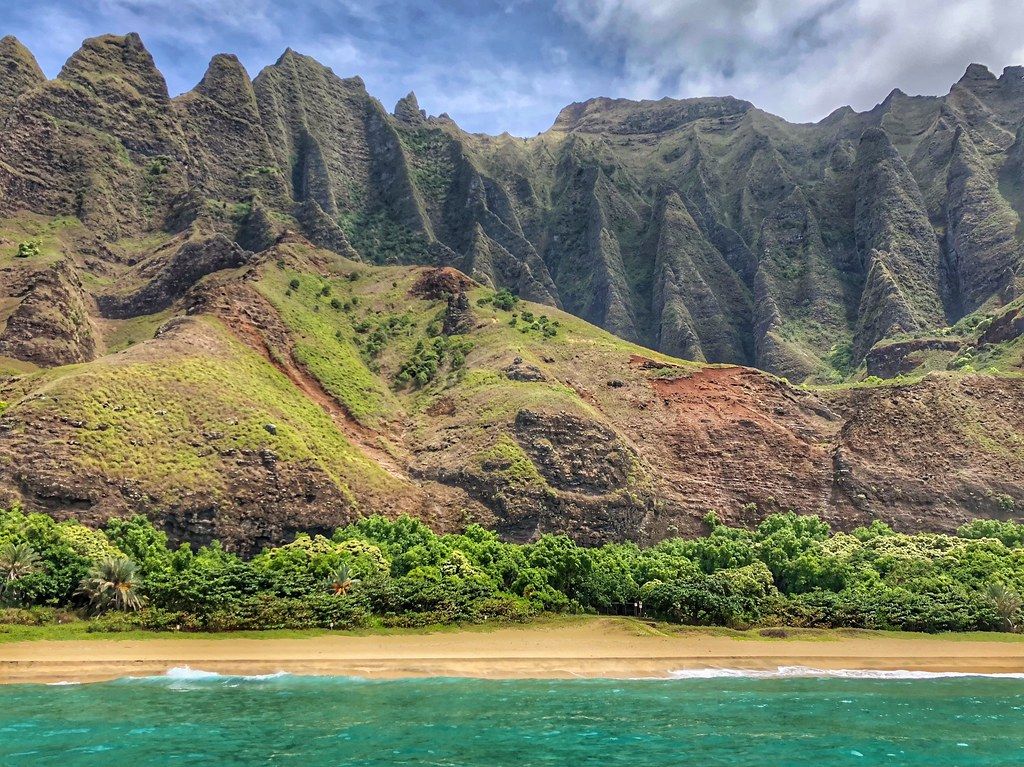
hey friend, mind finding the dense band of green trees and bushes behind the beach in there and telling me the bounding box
[0,509,1024,631]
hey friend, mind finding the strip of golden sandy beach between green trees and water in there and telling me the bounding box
[6,617,1024,684]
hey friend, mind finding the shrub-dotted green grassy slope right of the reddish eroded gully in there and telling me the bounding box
[251,245,697,484]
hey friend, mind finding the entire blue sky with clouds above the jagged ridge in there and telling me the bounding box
[6,0,1024,136]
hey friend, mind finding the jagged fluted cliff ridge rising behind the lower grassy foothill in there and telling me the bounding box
[0,35,1024,379]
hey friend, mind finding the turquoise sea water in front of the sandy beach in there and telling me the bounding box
[0,673,1024,767]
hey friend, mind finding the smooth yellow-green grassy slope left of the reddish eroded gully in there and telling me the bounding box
[10,319,385,500]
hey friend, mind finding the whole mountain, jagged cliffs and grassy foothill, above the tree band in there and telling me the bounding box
[0,35,1024,551]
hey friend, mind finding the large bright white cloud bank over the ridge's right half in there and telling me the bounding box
[556,0,1024,120]
